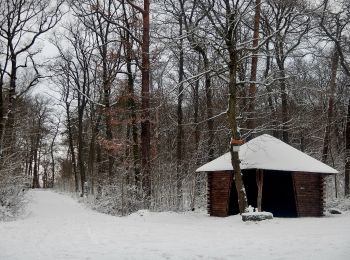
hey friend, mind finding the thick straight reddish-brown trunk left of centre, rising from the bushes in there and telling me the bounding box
[141,0,151,208]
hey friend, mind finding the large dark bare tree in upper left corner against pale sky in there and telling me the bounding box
[0,0,63,154]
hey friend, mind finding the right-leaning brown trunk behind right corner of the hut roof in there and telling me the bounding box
[322,49,339,163]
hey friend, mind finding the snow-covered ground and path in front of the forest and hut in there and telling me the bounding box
[0,190,350,260]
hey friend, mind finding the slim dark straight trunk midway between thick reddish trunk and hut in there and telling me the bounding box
[176,16,184,209]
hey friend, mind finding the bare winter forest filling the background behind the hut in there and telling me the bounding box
[0,0,350,219]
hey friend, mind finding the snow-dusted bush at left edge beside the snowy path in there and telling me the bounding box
[0,175,30,221]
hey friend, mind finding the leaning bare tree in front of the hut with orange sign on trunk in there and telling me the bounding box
[201,0,250,213]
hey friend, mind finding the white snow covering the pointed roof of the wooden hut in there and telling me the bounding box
[196,134,338,174]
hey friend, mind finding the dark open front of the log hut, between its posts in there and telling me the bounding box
[228,169,297,217]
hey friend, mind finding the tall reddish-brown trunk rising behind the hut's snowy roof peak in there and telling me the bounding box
[247,0,261,138]
